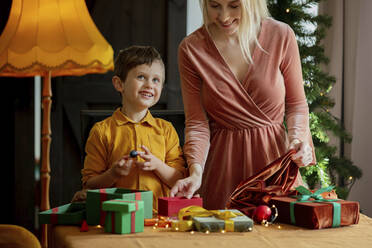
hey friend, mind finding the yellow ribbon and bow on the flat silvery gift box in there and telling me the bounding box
[178,206,243,232]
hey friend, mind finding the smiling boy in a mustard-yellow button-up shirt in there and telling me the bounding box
[74,46,185,209]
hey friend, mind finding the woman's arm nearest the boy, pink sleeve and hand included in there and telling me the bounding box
[170,40,210,198]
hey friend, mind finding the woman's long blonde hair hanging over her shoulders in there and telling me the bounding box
[199,0,269,64]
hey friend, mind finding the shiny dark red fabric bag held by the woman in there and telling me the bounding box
[227,150,299,216]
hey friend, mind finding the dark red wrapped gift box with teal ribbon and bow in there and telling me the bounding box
[270,186,359,229]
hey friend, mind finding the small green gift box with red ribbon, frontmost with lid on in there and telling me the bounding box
[102,199,144,234]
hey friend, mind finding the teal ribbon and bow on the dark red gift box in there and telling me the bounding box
[290,186,341,227]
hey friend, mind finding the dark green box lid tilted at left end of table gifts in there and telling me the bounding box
[39,202,86,225]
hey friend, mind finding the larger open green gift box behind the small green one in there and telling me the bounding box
[86,188,153,226]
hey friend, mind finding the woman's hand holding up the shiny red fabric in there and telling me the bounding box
[289,139,313,167]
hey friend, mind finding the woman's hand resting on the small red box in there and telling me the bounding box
[170,164,202,199]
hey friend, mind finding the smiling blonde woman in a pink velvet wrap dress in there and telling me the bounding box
[171,0,315,209]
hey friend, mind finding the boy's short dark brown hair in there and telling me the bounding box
[114,46,164,81]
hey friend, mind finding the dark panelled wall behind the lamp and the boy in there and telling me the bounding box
[0,0,186,230]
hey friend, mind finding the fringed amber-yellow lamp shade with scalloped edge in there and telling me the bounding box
[0,0,113,77]
